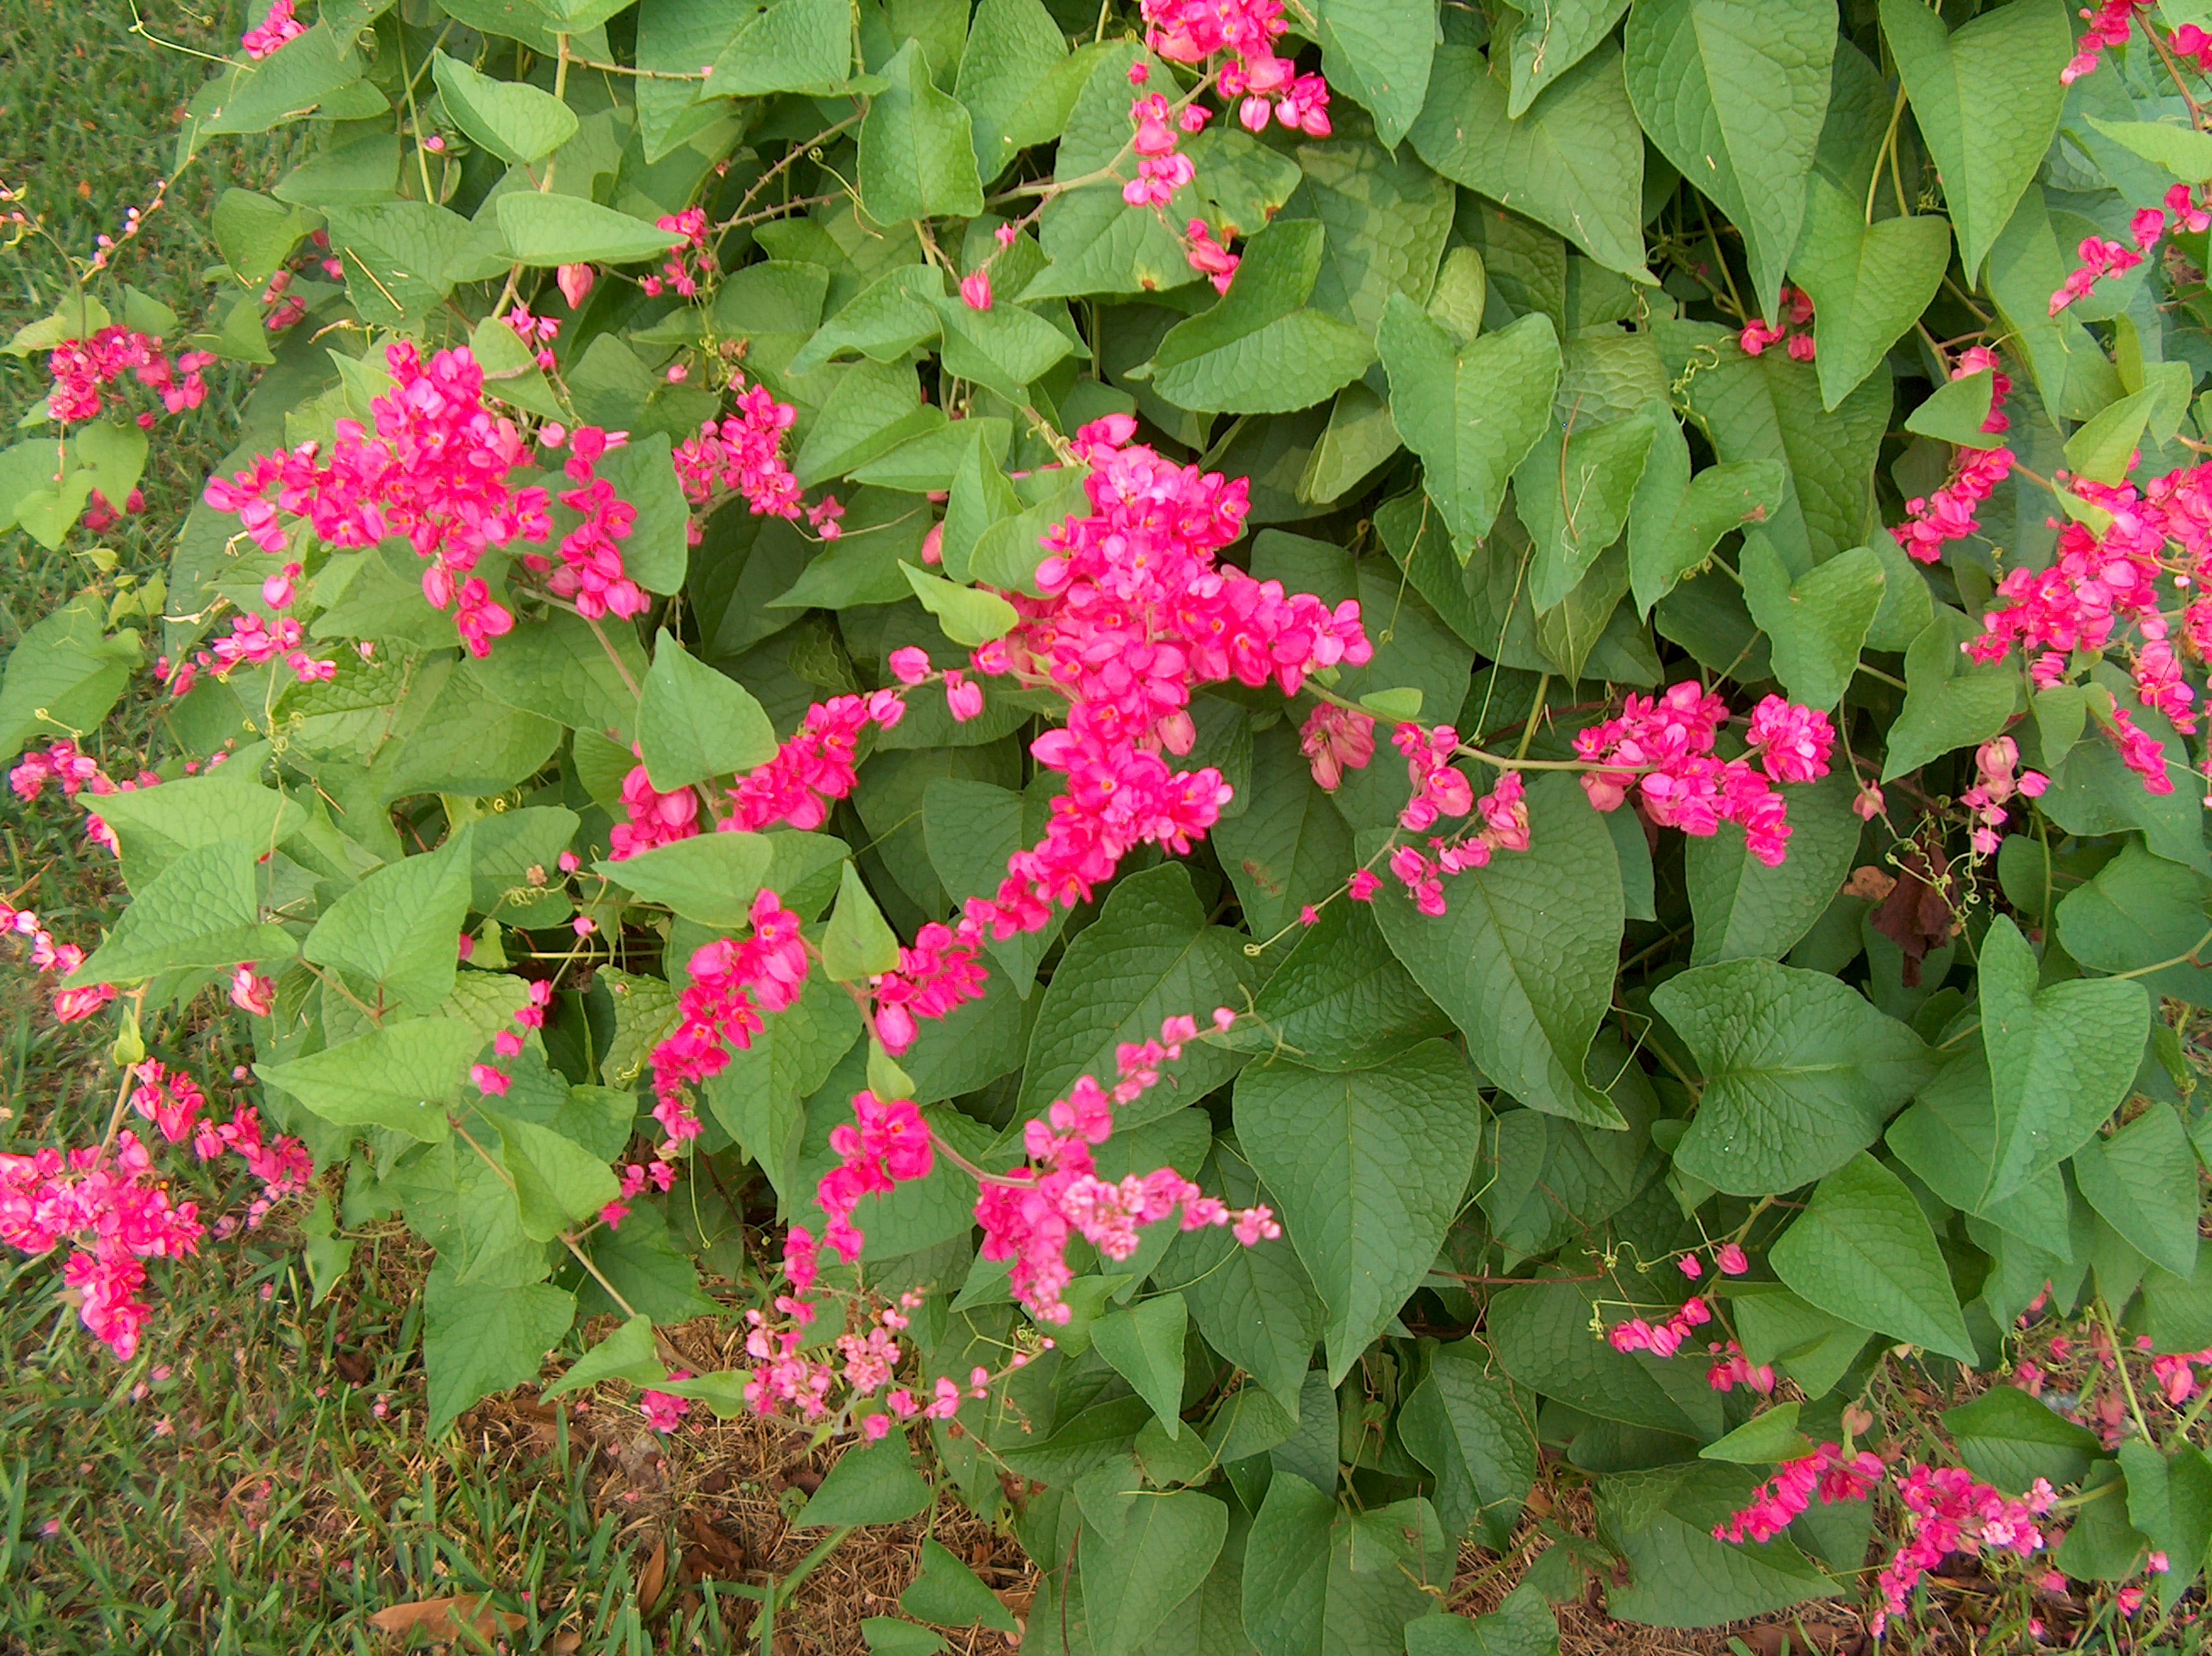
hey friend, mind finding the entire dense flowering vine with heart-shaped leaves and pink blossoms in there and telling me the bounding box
[13,0,2212,1656]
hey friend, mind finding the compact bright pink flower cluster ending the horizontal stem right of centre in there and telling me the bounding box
[1575,680,1836,868]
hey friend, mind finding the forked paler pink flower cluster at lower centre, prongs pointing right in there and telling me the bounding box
[975,1007,1283,1322]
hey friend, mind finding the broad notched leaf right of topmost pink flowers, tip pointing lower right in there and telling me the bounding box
[1407,40,1654,275]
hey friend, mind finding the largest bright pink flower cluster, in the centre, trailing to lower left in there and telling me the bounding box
[956,414,1374,945]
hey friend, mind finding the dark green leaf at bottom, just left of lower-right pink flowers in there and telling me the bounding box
[1597,1461,1838,1627]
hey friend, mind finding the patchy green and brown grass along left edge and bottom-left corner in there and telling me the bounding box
[0,0,699,1656]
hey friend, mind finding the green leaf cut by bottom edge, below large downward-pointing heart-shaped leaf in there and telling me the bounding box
[1243,1474,1451,1656]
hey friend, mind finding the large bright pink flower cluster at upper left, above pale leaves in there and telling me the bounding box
[204,341,553,646]
